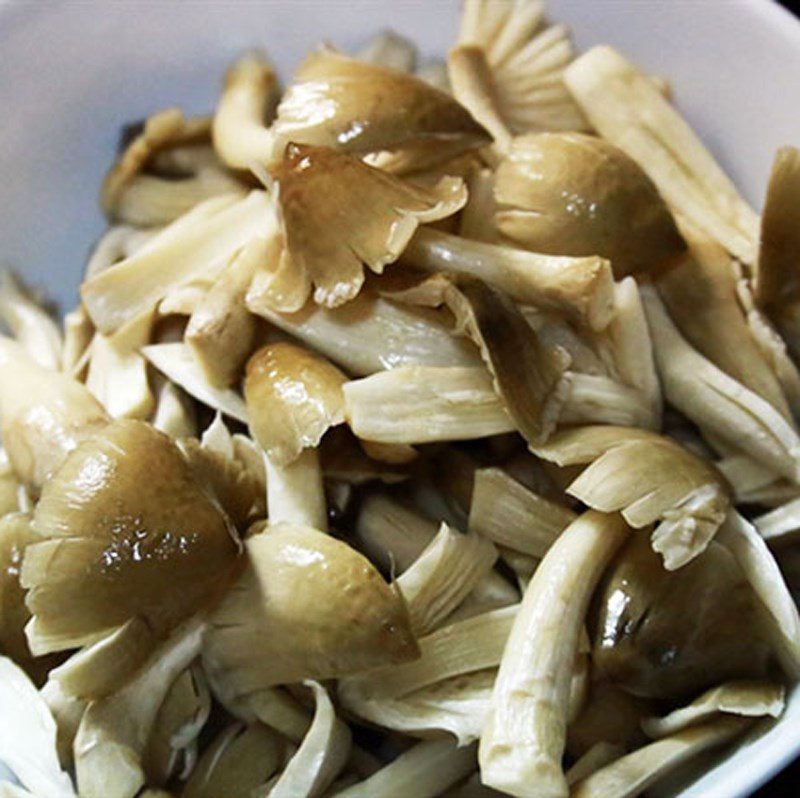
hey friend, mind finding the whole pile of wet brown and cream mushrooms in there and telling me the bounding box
[0,0,800,798]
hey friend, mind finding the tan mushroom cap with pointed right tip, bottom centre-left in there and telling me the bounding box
[206,524,418,694]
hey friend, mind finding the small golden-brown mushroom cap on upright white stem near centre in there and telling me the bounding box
[244,342,347,465]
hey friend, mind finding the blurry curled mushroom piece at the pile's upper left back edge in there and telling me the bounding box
[100,108,244,227]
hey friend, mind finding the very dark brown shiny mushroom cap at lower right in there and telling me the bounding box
[592,534,769,701]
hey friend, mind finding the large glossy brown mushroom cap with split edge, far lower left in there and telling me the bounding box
[23,420,239,650]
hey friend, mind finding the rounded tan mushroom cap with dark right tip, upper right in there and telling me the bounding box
[495,133,686,279]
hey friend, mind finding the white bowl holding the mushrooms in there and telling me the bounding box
[0,0,800,798]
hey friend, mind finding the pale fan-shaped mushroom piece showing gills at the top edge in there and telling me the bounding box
[447,0,586,141]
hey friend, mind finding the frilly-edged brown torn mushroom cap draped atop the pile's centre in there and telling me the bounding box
[265,143,467,312]
